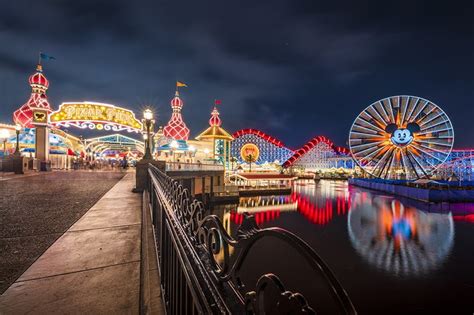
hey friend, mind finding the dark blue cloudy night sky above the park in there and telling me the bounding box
[0,0,474,148]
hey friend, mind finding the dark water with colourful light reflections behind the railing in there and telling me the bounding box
[212,180,474,314]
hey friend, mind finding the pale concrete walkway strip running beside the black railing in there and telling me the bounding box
[0,173,152,314]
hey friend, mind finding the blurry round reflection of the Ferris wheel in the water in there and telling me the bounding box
[347,198,454,275]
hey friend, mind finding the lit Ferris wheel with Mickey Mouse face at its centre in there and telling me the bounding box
[349,95,454,180]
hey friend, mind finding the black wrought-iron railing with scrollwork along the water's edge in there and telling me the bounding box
[148,165,356,314]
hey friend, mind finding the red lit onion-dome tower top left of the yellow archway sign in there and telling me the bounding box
[13,65,52,128]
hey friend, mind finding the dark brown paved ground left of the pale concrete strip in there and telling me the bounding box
[0,171,123,293]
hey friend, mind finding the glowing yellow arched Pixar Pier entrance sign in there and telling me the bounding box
[49,102,143,132]
